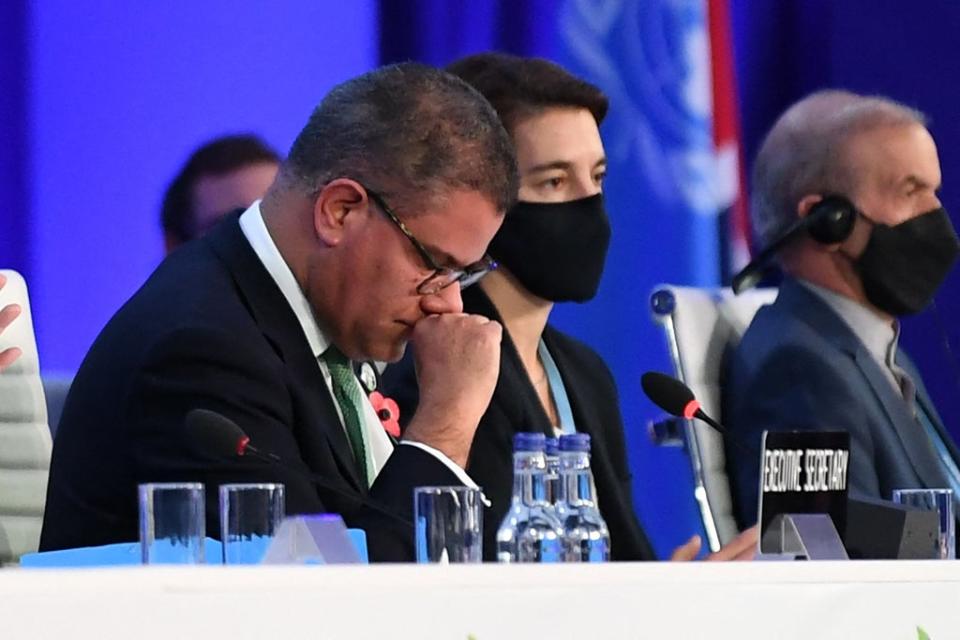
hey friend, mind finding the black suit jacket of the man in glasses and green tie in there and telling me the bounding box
[40,215,458,560]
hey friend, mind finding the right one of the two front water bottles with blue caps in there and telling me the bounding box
[556,433,610,562]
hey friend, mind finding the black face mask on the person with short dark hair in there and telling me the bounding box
[489,193,610,302]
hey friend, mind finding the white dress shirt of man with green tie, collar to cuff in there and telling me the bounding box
[240,200,477,488]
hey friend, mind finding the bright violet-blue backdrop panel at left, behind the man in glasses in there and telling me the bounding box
[0,0,378,372]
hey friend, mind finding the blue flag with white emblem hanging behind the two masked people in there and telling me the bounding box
[552,0,739,557]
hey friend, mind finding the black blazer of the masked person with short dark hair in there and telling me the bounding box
[383,287,656,560]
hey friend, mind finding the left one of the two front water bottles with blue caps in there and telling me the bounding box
[497,433,563,562]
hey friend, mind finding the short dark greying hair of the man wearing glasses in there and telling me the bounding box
[281,62,519,214]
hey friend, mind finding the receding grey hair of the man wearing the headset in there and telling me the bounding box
[750,90,927,246]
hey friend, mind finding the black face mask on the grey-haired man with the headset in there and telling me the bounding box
[856,207,960,316]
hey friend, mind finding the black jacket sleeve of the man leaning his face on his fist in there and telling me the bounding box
[128,328,456,561]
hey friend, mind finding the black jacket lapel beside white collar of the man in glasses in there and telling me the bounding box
[207,215,366,492]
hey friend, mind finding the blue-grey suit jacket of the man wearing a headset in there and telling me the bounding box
[723,278,958,526]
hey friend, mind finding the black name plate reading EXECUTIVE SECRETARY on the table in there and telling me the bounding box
[759,431,850,553]
